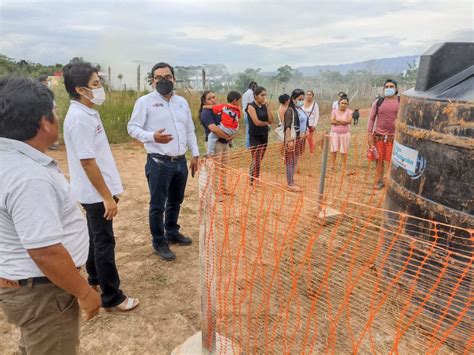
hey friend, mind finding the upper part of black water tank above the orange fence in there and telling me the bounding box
[387,43,474,228]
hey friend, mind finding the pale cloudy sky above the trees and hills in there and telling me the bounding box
[0,0,474,83]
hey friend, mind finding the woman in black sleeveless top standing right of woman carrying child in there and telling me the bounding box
[247,86,273,184]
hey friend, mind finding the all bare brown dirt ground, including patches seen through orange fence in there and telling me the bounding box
[0,130,466,354]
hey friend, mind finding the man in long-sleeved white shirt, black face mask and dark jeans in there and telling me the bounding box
[128,63,199,261]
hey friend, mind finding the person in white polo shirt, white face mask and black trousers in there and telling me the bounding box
[63,62,138,312]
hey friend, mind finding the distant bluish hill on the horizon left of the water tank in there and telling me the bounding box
[296,55,420,76]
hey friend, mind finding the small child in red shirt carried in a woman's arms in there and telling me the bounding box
[207,91,242,155]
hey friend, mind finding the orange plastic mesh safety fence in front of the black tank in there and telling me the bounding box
[196,132,474,354]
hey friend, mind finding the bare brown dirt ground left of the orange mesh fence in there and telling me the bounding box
[0,143,200,354]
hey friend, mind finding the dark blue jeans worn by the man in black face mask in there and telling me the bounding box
[145,154,188,248]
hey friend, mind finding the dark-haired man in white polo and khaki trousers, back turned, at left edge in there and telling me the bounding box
[0,77,100,354]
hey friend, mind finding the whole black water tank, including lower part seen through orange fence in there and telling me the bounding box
[383,43,474,352]
